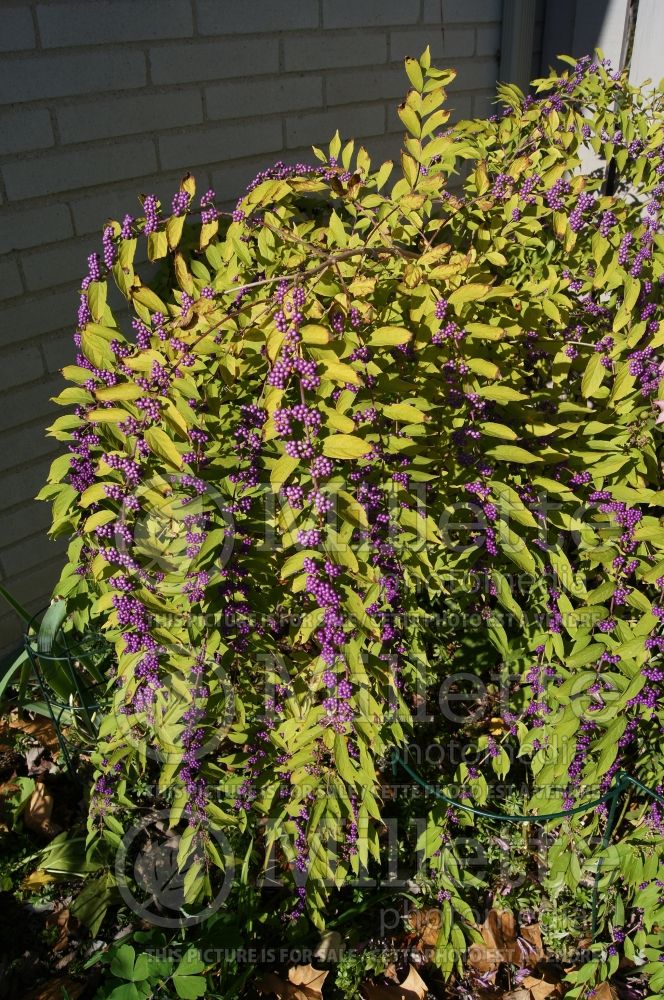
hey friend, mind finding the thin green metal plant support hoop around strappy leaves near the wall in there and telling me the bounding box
[23,606,104,780]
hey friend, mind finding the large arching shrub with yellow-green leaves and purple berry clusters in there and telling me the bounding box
[41,52,664,971]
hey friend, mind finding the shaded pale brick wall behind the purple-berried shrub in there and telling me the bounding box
[0,0,502,652]
